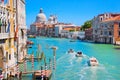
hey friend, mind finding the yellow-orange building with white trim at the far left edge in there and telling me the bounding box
[0,0,17,78]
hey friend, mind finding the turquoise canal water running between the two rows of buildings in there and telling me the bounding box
[23,37,120,80]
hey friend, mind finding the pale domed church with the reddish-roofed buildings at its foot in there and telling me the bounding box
[30,8,58,35]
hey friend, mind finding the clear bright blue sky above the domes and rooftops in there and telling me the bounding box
[26,0,120,27]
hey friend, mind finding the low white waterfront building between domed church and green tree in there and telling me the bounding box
[55,24,80,38]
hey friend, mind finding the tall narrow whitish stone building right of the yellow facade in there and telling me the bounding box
[16,0,27,61]
